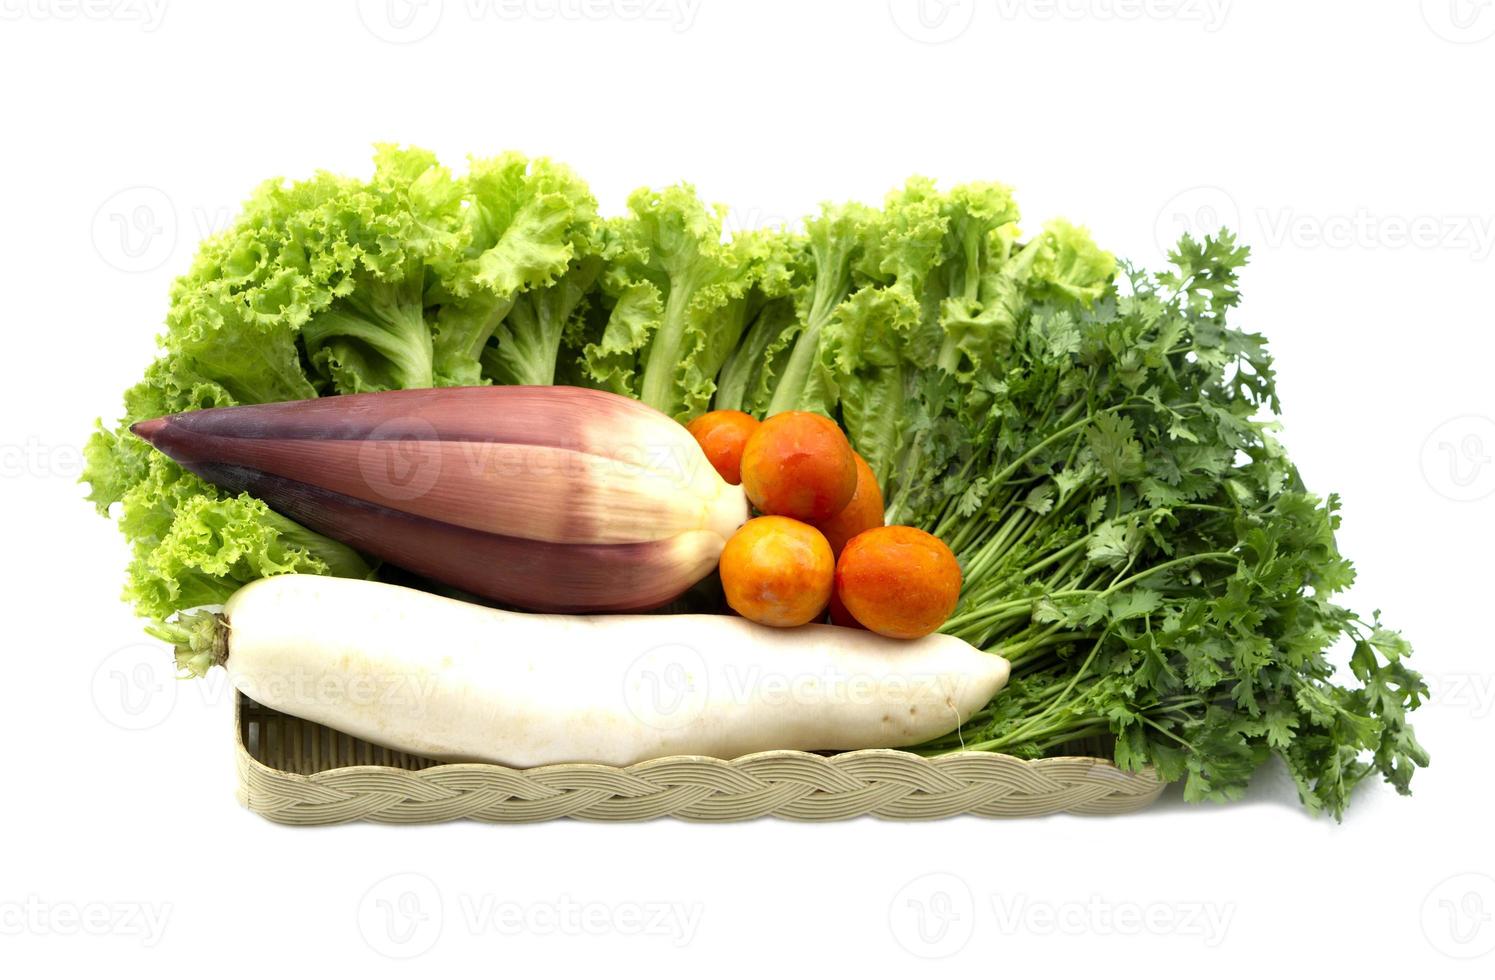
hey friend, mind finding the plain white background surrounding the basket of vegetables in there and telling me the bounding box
[0,0,1495,977]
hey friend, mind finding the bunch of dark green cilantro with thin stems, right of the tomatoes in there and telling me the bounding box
[896,233,1428,816]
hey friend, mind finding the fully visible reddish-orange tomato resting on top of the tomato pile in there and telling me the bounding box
[742,412,857,524]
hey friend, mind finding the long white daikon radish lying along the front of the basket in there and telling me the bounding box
[169,575,1008,766]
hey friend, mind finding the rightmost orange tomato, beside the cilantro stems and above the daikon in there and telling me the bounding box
[836,526,960,639]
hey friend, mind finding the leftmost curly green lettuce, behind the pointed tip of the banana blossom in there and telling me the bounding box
[82,146,478,618]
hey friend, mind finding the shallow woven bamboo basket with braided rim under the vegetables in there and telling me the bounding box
[235,695,1163,826]
